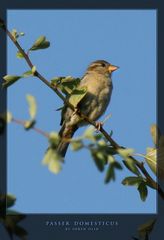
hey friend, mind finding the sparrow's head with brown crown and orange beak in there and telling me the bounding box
[87,60,118,75]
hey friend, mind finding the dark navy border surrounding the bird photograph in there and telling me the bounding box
[0,0,164,240]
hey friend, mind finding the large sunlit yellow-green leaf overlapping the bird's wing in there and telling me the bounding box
[69,86,87,107]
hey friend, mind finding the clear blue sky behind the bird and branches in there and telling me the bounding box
[7,10,157,213]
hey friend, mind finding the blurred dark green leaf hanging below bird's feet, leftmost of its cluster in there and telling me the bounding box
[90,149,106,172]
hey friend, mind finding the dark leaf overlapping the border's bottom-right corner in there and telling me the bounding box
[138,219,156,238]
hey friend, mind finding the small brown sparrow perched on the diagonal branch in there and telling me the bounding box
[57,60,119,159]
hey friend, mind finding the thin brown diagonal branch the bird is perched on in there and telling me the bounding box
[0,16,164,199]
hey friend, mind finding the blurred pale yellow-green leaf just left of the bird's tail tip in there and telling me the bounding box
[42,148,63,174]
